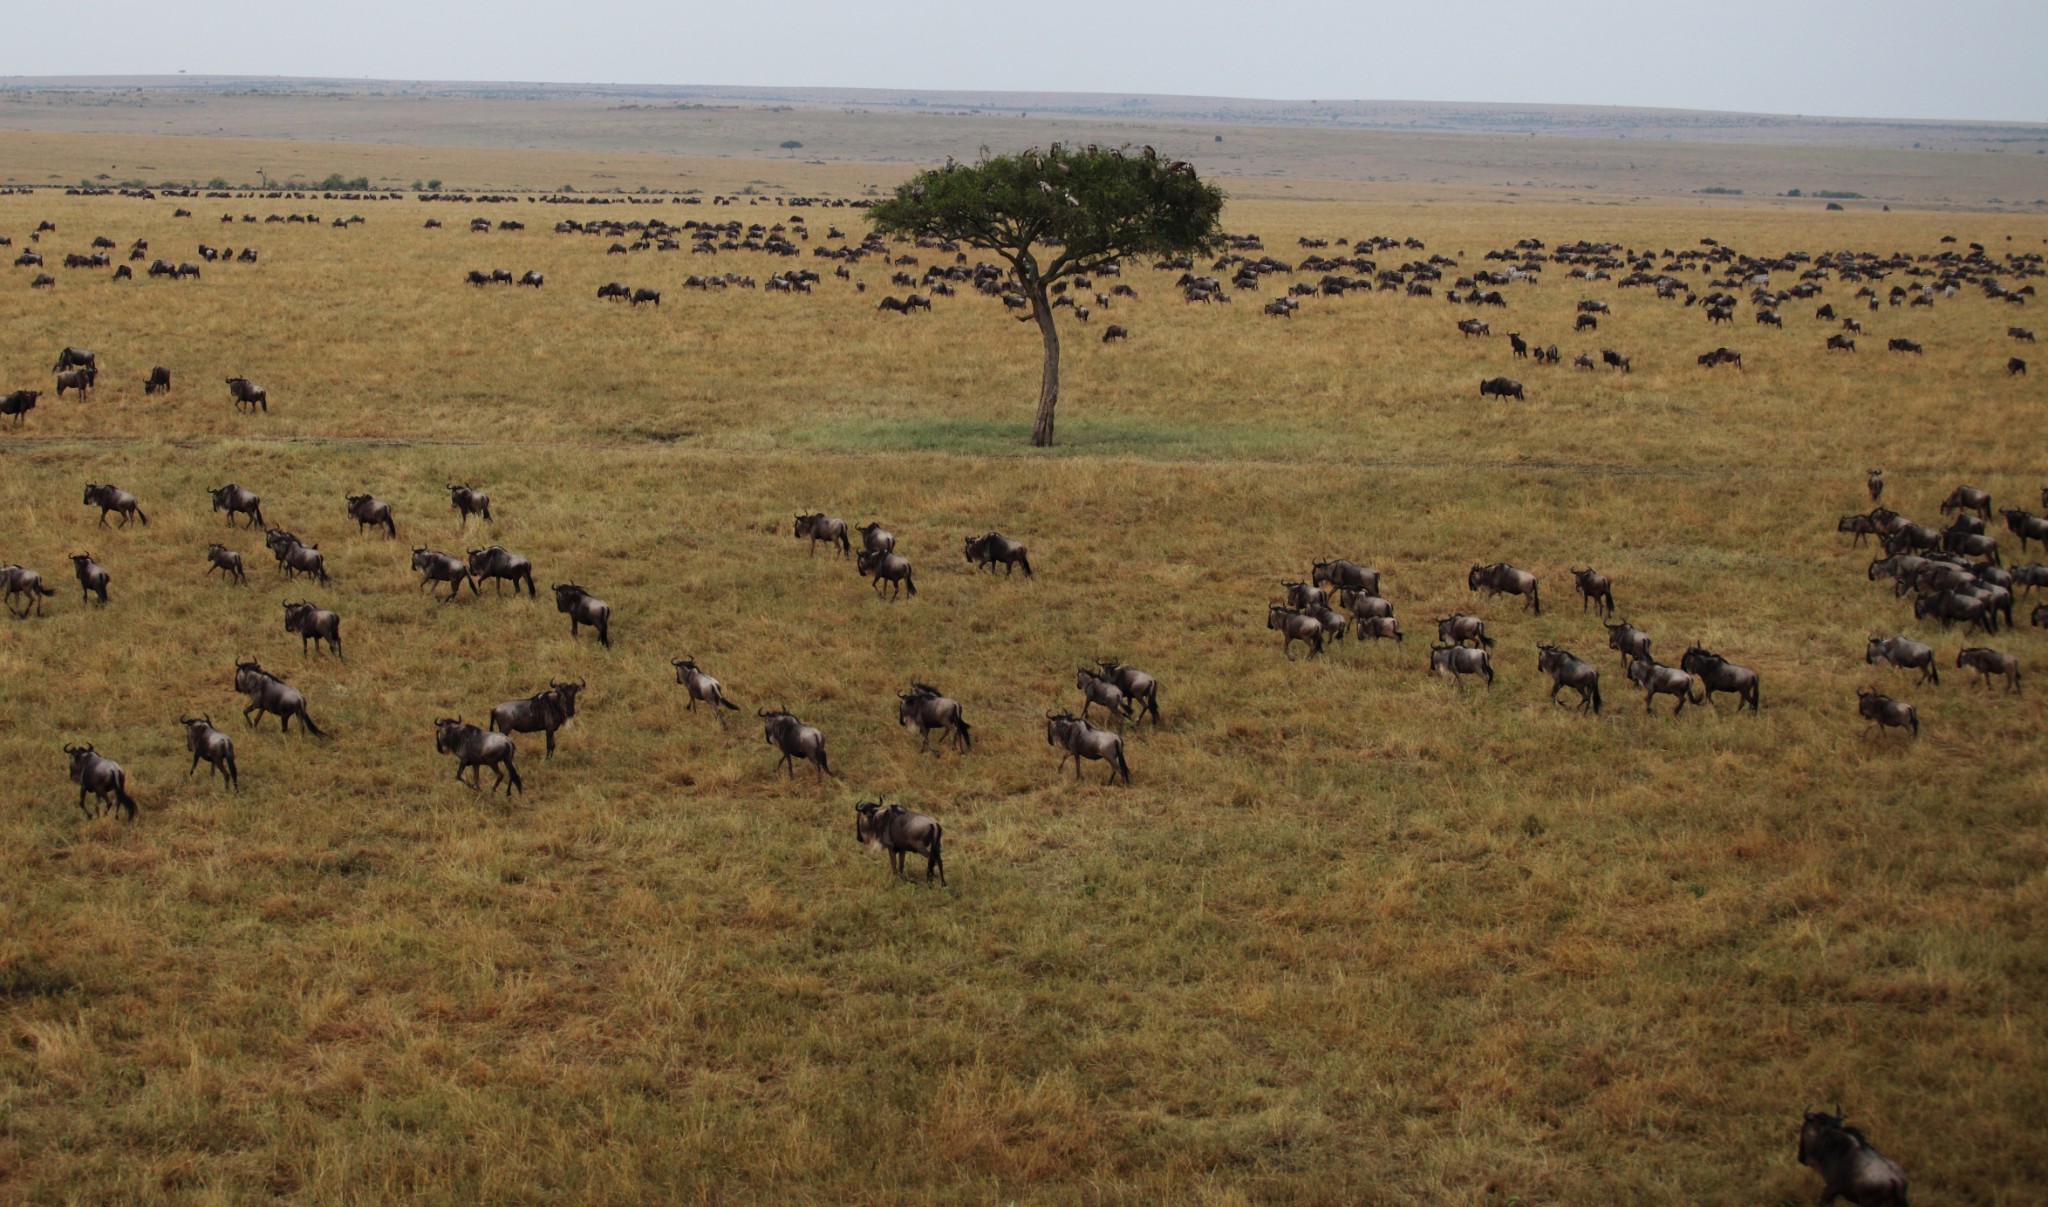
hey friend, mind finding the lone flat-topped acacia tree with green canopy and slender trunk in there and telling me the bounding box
[868,143,1223,449]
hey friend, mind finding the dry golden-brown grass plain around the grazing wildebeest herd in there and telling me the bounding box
[0,167,2048,1205]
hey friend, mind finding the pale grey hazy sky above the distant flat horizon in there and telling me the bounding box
[16,0,2048,121]
